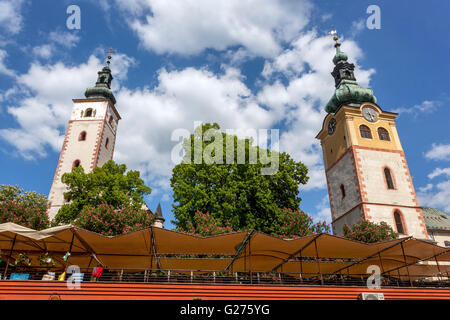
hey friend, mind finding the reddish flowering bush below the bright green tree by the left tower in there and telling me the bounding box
[74,203,156,236]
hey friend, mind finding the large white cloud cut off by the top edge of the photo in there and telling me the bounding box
[116,0,311,57]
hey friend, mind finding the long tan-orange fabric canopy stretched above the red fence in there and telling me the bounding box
[0,223,450,277]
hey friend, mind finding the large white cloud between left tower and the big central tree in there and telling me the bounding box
[115,68,272,188]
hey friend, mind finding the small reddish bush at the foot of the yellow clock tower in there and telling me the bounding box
[343,220,398,243]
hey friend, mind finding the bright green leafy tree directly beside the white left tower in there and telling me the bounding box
[55,160,151,224]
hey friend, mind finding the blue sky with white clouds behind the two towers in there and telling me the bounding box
[0,0,450,228]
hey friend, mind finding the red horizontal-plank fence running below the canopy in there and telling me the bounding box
[0,281,450,300]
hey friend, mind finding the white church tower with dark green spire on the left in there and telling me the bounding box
[48,52,120,219]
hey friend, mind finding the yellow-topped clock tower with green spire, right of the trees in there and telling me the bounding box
[316,39,430,239]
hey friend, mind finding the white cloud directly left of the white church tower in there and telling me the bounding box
[0,56,132,159]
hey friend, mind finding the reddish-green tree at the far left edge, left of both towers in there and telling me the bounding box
[0,185,49,230]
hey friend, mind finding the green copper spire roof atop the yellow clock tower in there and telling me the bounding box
[325,38,377,113]
